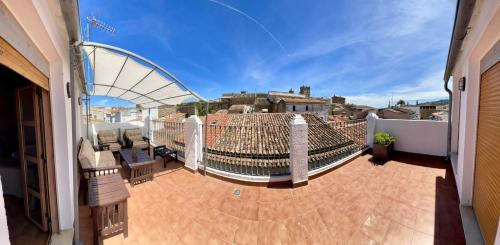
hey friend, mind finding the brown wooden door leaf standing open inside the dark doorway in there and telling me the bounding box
[16,85,49,231]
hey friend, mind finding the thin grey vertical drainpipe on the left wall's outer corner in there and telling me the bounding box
[69,43,81,244]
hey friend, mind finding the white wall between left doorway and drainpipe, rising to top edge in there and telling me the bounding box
[1,0,74,230]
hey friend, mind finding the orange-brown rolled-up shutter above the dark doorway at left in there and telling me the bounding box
[0,37,49,91]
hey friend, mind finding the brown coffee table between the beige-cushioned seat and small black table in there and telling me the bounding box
[120,149,155,186]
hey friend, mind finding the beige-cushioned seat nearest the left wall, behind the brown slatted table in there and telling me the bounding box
[78,138,121,204]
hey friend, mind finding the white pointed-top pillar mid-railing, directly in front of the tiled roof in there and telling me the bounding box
[289,114,308,186]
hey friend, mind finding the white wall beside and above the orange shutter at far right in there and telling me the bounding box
[452,0,500,206]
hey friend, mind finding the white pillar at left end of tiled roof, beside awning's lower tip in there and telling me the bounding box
[184,115,202,171]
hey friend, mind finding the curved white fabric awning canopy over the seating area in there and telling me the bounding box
[79,42,207,108]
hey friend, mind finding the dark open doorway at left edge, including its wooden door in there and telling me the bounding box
[0,64,55,244]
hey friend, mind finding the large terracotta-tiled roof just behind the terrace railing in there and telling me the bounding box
[207,113,357,168]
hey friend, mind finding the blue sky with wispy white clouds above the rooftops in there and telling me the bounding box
[80,0,456,107]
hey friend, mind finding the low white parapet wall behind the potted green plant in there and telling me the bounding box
[375,119,448,156]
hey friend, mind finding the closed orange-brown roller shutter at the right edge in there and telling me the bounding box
[472,62,500,244]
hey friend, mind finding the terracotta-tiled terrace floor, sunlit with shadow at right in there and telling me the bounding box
[80,154,465,244]
